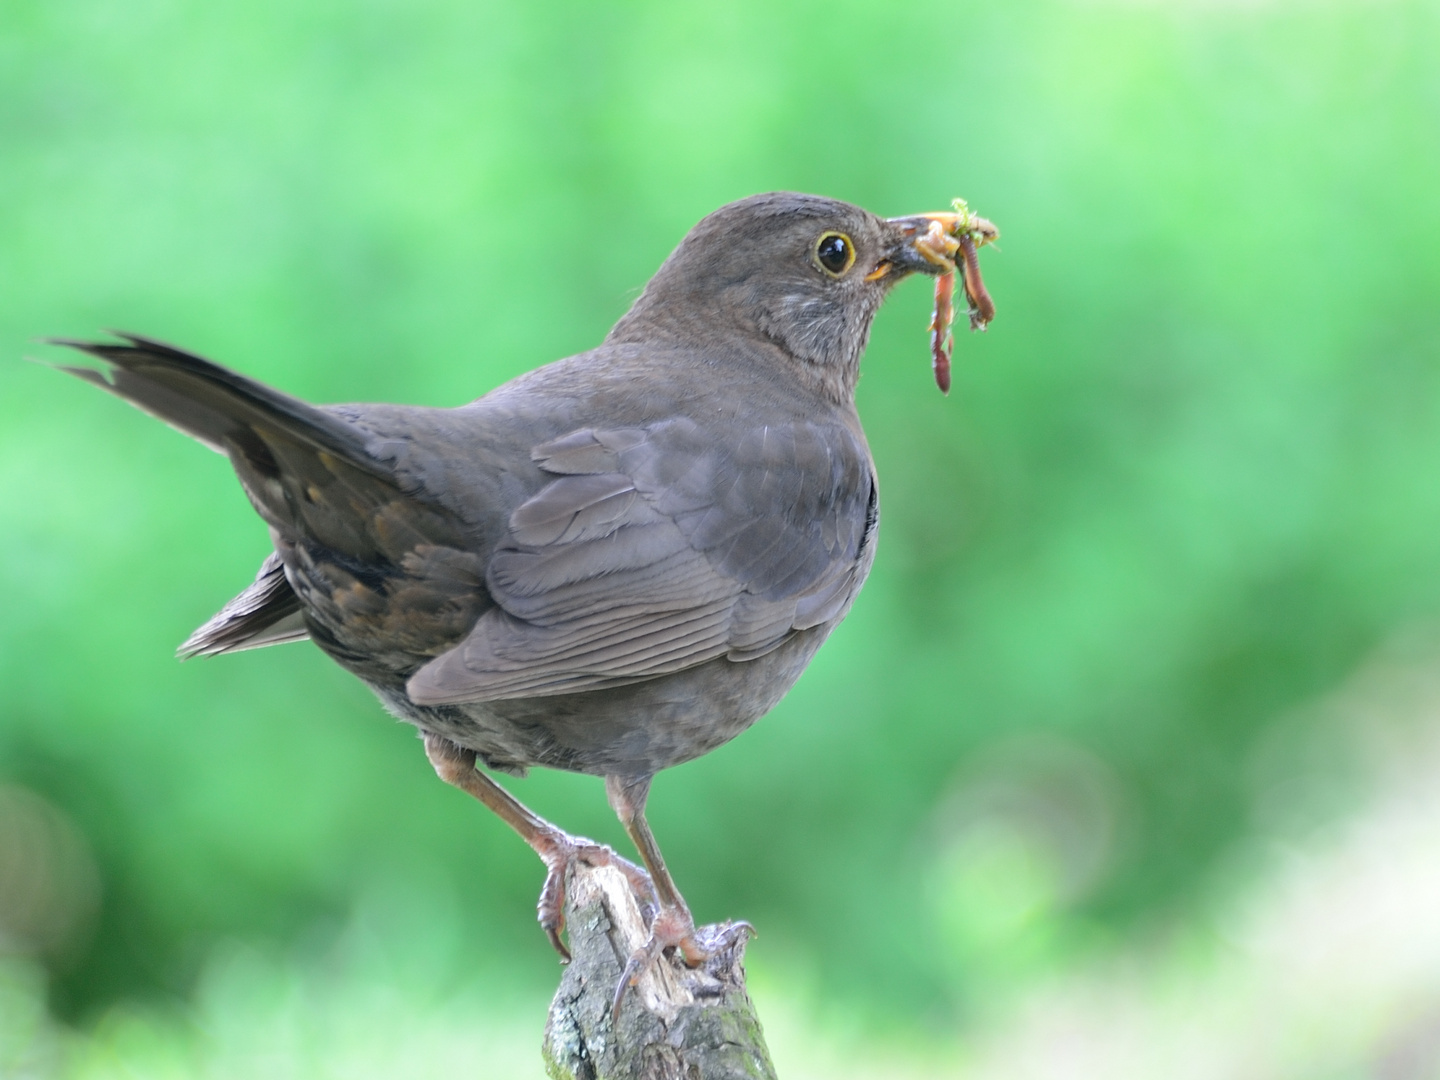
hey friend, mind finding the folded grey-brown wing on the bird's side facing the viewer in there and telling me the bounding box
[408,419,876,704]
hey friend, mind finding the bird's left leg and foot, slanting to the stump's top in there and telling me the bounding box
[425,732,654,963]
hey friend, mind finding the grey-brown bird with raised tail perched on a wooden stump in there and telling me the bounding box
[56,192,995,1009]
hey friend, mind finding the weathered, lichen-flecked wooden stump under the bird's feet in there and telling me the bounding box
[543,865,775,1080]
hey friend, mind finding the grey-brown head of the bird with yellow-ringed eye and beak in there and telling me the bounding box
[608,192,994,400]
